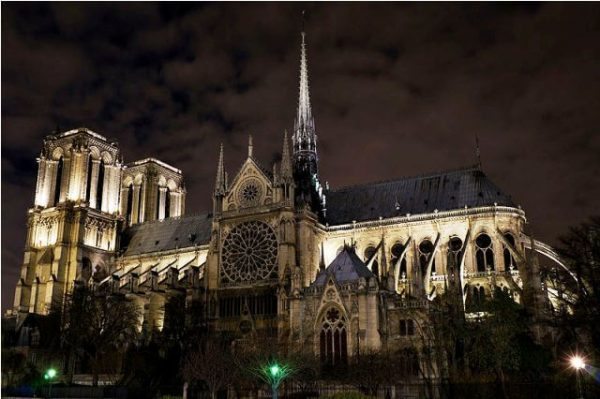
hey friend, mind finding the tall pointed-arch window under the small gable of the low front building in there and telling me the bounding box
[320,307,348,366]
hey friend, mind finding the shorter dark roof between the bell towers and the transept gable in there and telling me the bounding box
[121,214,212,256]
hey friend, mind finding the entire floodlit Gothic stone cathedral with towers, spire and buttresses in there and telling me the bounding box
[11,33,564,363]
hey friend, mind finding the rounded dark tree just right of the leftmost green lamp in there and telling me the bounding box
[62,286,140,386]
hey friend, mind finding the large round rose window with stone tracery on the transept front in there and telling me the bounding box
[221,221,277,282]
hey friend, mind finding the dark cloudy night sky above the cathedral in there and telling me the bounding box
[2,3,600,311]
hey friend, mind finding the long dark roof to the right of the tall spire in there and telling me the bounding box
[326,167,515,225]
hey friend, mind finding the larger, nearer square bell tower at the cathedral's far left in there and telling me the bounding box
[14,128,121,317]
